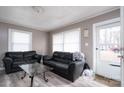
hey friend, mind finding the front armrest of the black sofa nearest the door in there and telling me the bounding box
[68,61,85,81]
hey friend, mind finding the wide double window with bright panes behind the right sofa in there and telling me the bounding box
[53,29,80,52]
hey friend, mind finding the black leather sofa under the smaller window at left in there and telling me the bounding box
[3,51,41,74]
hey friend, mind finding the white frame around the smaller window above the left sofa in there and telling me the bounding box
[8,28,32,51]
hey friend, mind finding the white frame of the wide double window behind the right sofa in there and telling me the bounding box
[52,28,81,52]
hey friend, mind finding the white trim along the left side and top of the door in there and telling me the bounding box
[92,17,120,77]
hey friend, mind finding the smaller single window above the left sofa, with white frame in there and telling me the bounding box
[8,29,32,51]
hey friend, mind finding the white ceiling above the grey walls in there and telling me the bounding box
[0,6,118,31]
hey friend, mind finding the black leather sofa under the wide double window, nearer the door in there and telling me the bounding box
[43,51,87,82]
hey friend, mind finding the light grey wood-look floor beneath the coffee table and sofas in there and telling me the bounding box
[0,71,107,87]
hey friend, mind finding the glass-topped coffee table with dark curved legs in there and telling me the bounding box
[19,63,53,87]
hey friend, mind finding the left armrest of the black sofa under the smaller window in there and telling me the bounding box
[3,57,13,73]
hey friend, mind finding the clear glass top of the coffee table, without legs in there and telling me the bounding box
[19,62,52,76]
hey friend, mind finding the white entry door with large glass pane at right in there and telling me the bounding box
[96,18,121,81]
